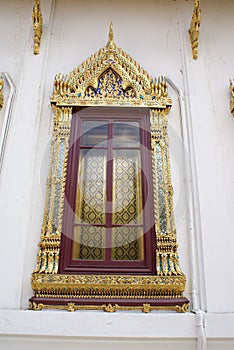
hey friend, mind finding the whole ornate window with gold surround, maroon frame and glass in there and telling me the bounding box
[30,26,188,312]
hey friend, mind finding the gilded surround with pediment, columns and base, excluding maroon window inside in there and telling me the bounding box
[29,25,189,312]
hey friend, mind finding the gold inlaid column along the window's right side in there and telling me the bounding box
[150,109,182,276]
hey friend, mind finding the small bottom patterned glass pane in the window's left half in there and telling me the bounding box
[72,226,105,260]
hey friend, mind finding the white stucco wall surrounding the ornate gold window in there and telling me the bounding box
[0,0,234,349]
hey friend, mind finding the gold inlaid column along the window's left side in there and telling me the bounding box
[34,107,72,273]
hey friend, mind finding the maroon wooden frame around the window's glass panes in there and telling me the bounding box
[59,107,156,274]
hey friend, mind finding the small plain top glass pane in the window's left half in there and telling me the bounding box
[81,121,108,147]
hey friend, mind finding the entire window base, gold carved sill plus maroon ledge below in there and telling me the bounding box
[29,273,189,313]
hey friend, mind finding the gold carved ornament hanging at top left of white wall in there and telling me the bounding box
[32,0,42,55]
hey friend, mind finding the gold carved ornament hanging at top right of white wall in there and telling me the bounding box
[189,0,201,60]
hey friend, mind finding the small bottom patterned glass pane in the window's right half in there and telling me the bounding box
[112,226,144,260]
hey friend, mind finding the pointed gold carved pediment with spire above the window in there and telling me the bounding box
[51,25,171,108]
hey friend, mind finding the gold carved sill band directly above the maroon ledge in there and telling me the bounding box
[32,273,186,300]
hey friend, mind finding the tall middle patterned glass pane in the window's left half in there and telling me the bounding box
[75,148,107,224]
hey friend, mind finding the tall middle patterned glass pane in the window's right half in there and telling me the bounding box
[112,149,142,224]
